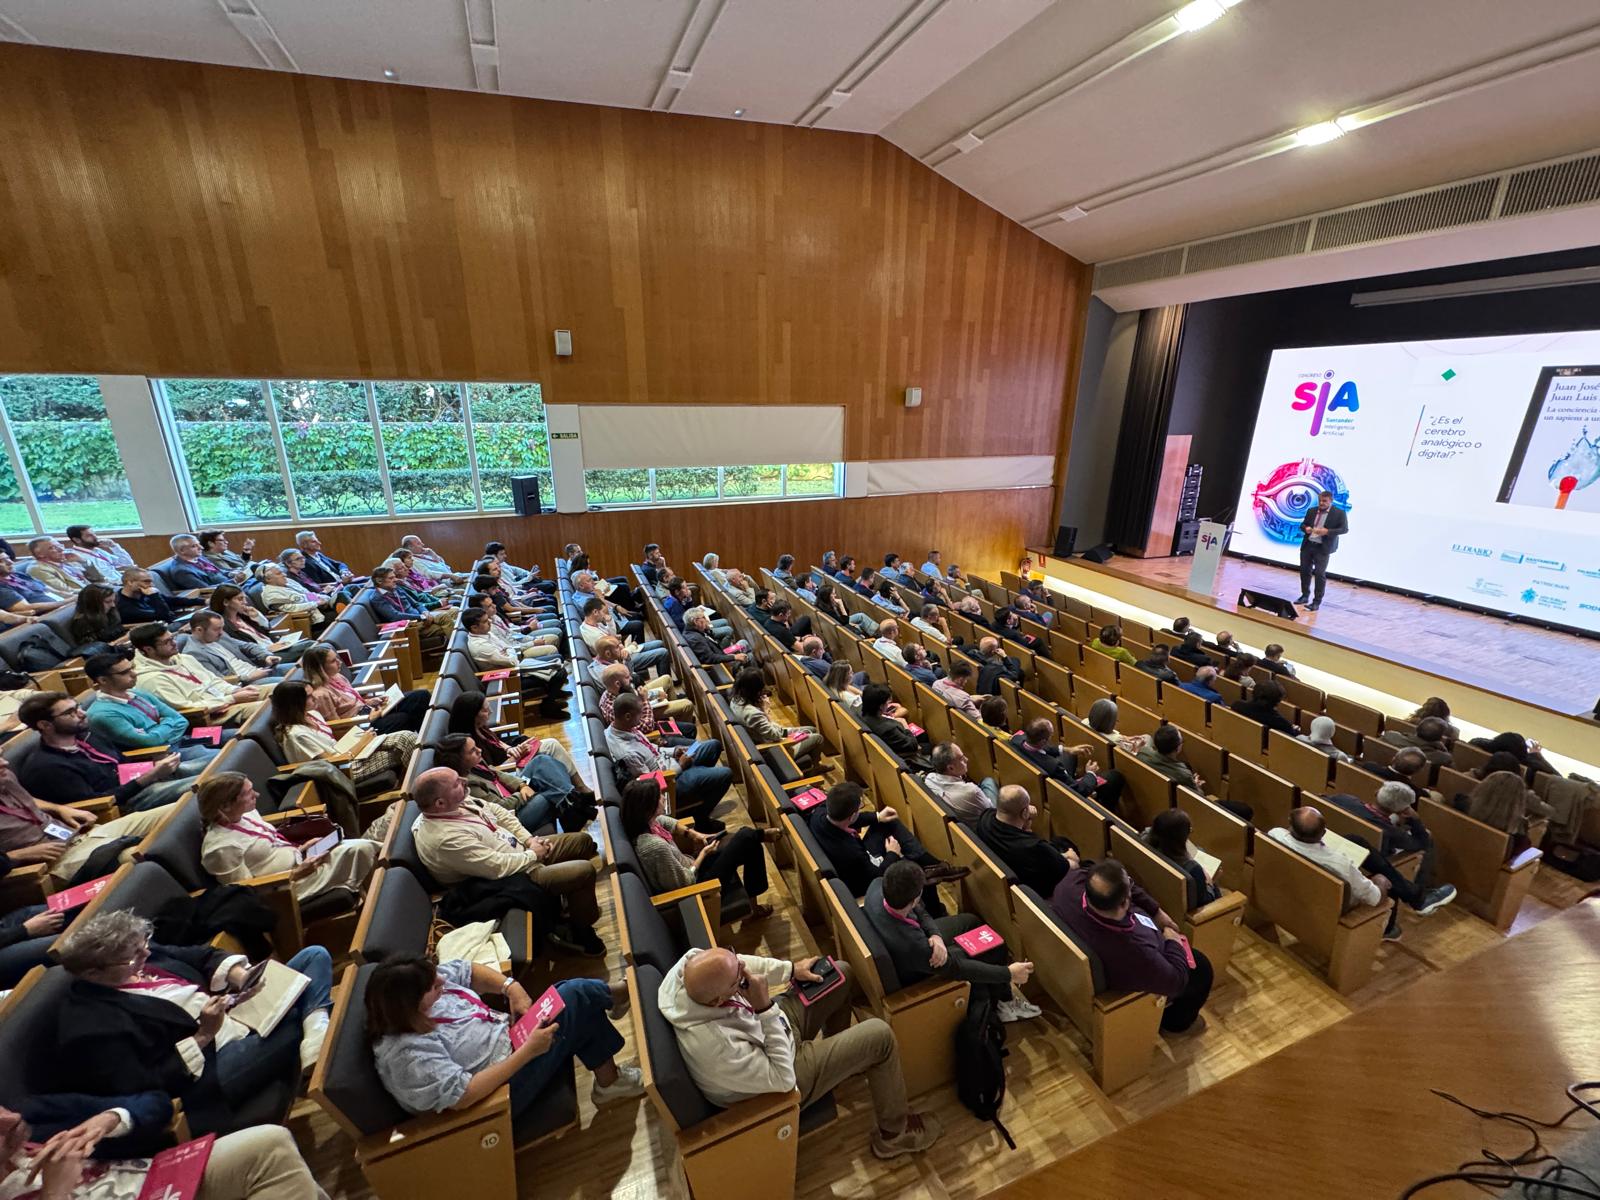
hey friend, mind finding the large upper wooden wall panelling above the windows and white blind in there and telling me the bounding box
[0,43,1090,464]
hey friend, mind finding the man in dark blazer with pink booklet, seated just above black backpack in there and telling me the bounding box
[861,859,1045,1024]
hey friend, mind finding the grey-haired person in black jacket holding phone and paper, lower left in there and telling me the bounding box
[50,910,333,1136]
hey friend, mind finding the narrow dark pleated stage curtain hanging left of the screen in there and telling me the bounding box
[1106,304,1184,549]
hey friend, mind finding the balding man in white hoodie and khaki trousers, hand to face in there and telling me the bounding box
[658,949,941,1158]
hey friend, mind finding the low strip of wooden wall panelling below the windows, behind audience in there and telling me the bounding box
[117,488,1053,578]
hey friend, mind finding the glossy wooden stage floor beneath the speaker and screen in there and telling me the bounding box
[1107,555,1600,715]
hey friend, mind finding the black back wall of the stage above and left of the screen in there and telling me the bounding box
[1166,246,1600,517]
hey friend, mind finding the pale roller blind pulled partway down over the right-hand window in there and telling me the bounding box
[578,405,845,469]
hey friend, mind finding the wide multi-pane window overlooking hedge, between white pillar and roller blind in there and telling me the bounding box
[154,379,554,525]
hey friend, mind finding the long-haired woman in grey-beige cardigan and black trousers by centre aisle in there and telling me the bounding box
[622,778,778,920]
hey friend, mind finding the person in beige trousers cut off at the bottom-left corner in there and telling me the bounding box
[0,1091,328,1200]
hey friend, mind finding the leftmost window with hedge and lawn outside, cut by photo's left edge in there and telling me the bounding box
[0,374,139,536]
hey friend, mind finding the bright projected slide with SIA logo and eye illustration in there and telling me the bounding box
[1230,331,1600,632]
